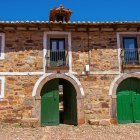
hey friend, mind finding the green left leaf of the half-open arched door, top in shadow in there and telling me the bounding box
[41,79,59,126]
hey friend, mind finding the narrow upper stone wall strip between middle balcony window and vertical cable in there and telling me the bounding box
[72,32,88,73]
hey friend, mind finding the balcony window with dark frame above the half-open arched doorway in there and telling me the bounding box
[50,39,66,66]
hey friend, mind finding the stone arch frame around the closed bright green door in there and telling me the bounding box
[109,73,140,118]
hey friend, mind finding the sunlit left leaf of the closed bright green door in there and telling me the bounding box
[117,91,134,123]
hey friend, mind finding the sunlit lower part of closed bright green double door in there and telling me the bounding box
[117,91,140,123]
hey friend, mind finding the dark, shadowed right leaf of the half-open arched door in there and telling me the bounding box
[63,81,77,125]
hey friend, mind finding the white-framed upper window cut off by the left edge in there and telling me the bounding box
[0,33,5,59]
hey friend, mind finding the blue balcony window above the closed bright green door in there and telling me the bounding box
[123,37,139,63]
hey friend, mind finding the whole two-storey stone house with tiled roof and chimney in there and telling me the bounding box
[0,6,140,125]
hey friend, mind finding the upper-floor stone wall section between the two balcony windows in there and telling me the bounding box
[72,32,119,73]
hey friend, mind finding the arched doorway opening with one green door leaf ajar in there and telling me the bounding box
[41,78,77,125]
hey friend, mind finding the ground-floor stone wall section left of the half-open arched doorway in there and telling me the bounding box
[0,75,39,120]
